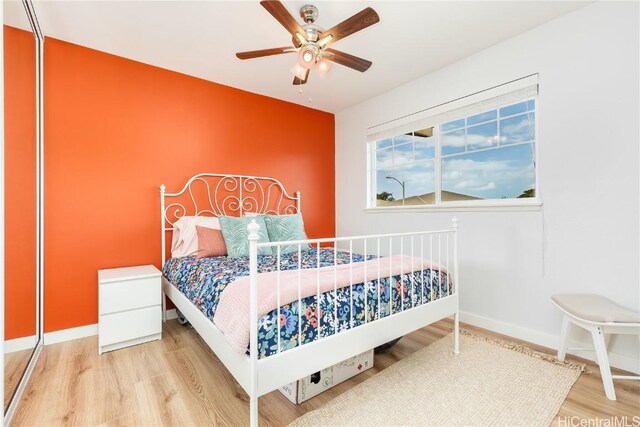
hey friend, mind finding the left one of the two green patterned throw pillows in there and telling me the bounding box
[218,216,271,258]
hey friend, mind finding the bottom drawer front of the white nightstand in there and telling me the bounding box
[98,305,162,347]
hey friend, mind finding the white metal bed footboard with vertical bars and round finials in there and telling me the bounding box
[246,218,460,426]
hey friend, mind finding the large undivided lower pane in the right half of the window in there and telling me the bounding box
[442,144,535,201]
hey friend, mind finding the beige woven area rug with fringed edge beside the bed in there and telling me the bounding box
[290,334,584,426]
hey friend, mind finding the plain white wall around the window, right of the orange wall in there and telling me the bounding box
[336,2,640,371]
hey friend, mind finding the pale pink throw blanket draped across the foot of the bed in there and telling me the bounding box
[213,255,446,353]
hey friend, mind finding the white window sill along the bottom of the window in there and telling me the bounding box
[364,200,542,214]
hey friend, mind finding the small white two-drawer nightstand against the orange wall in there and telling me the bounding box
[98,265,162,354]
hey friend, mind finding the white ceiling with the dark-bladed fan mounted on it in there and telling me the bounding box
[4,0,587,112]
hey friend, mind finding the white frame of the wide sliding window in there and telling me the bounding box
[365,74,542,213]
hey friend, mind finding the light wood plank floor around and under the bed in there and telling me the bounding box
[13,320,640,426]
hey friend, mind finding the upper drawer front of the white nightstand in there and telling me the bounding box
[99,277,162,314]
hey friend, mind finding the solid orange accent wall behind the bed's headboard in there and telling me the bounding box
[44,38,335,332]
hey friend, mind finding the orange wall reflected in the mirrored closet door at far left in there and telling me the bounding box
[3,26,36,340]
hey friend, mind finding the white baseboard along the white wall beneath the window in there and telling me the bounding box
[460,311,640,374]
